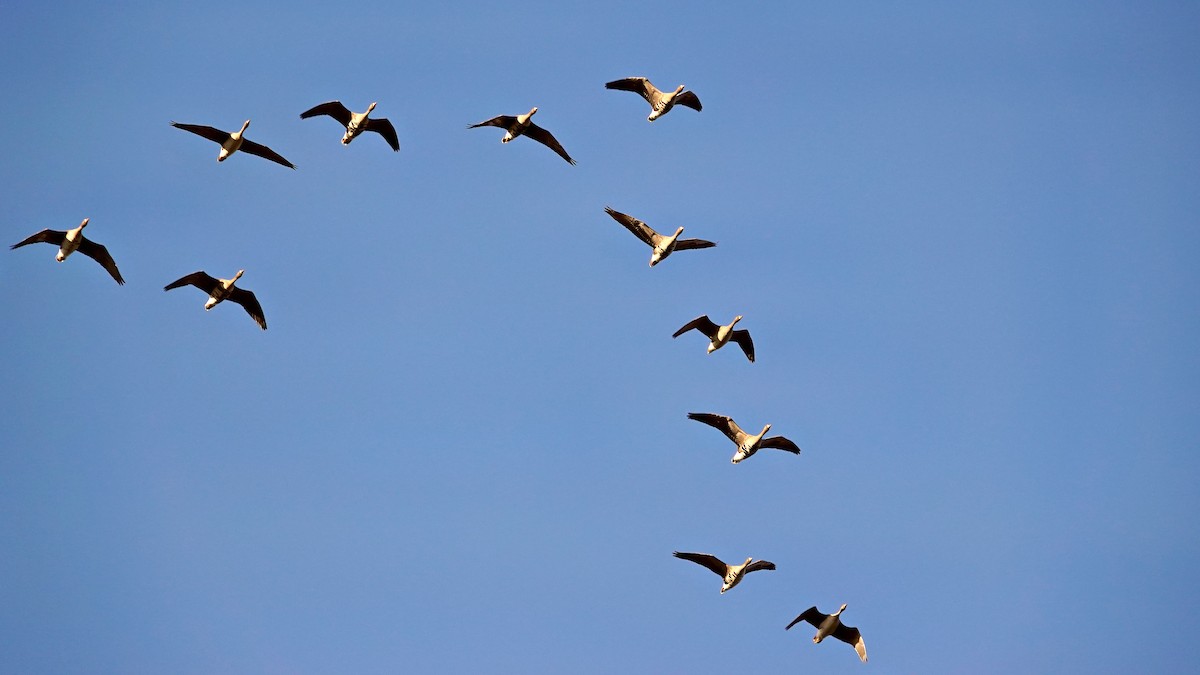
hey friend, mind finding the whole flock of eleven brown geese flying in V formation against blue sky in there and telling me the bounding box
[11,77,866,662]
